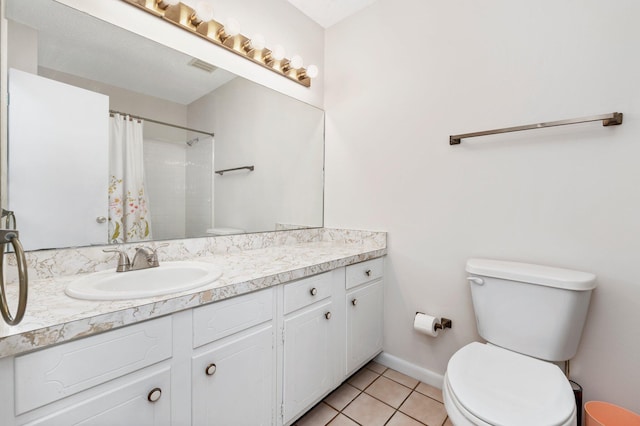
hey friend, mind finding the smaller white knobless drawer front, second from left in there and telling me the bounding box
[193,288,273,348]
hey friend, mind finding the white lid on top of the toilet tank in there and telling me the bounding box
[466,258,596,291]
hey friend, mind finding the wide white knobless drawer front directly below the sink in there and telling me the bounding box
[14,317,172,414]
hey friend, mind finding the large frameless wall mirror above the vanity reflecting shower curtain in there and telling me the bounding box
[3,0,324,250]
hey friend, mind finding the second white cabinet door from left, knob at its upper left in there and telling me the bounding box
[191,324,275,426]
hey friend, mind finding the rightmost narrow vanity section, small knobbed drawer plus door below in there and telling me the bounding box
[346,259,384,376]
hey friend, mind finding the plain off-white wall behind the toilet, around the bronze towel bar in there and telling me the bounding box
[325,0,640,412]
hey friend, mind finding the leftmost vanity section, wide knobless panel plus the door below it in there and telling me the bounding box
[8,317,172,426]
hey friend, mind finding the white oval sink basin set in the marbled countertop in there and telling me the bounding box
[64,262,222,300]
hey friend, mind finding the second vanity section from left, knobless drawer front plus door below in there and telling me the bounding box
[191,289,276,426]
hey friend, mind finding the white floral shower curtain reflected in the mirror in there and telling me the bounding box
[109,114,152,243]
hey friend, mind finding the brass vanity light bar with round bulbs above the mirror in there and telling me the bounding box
[122,0,318,87]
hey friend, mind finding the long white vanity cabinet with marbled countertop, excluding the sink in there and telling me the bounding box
[0,230,386,425]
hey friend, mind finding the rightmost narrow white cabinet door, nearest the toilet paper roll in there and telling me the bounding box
[347,280,384,375]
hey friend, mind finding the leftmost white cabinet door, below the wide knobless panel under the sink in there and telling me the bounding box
[19,366,171,426]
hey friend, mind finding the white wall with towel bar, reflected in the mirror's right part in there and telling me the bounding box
[188,78,323,232]
